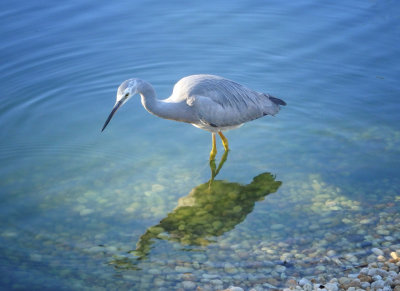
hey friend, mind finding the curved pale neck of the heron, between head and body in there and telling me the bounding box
[138,81,195,123]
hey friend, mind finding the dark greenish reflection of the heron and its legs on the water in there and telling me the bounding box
[128,152,282,259]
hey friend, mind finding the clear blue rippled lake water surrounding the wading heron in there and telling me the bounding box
[0,0,400,290]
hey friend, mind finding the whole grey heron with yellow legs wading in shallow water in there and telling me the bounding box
[101,75,286,160]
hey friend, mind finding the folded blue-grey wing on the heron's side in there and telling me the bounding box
[188,79,283,127]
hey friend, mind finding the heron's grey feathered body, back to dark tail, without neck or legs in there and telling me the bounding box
[167,75,285,131]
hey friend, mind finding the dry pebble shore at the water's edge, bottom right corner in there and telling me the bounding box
[223,249,400,291]
